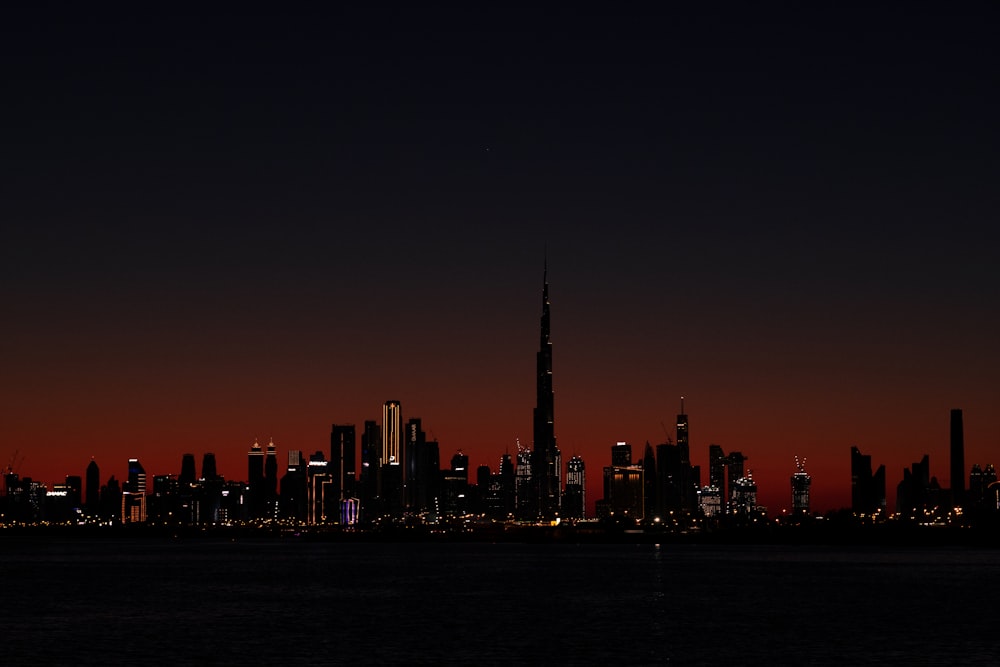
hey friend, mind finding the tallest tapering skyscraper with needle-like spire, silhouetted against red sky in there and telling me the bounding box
[531,258,562,519]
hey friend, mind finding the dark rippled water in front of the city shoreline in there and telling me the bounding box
[0,538,1000,666]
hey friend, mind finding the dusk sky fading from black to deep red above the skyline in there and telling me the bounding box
[0,3,1000,514]
